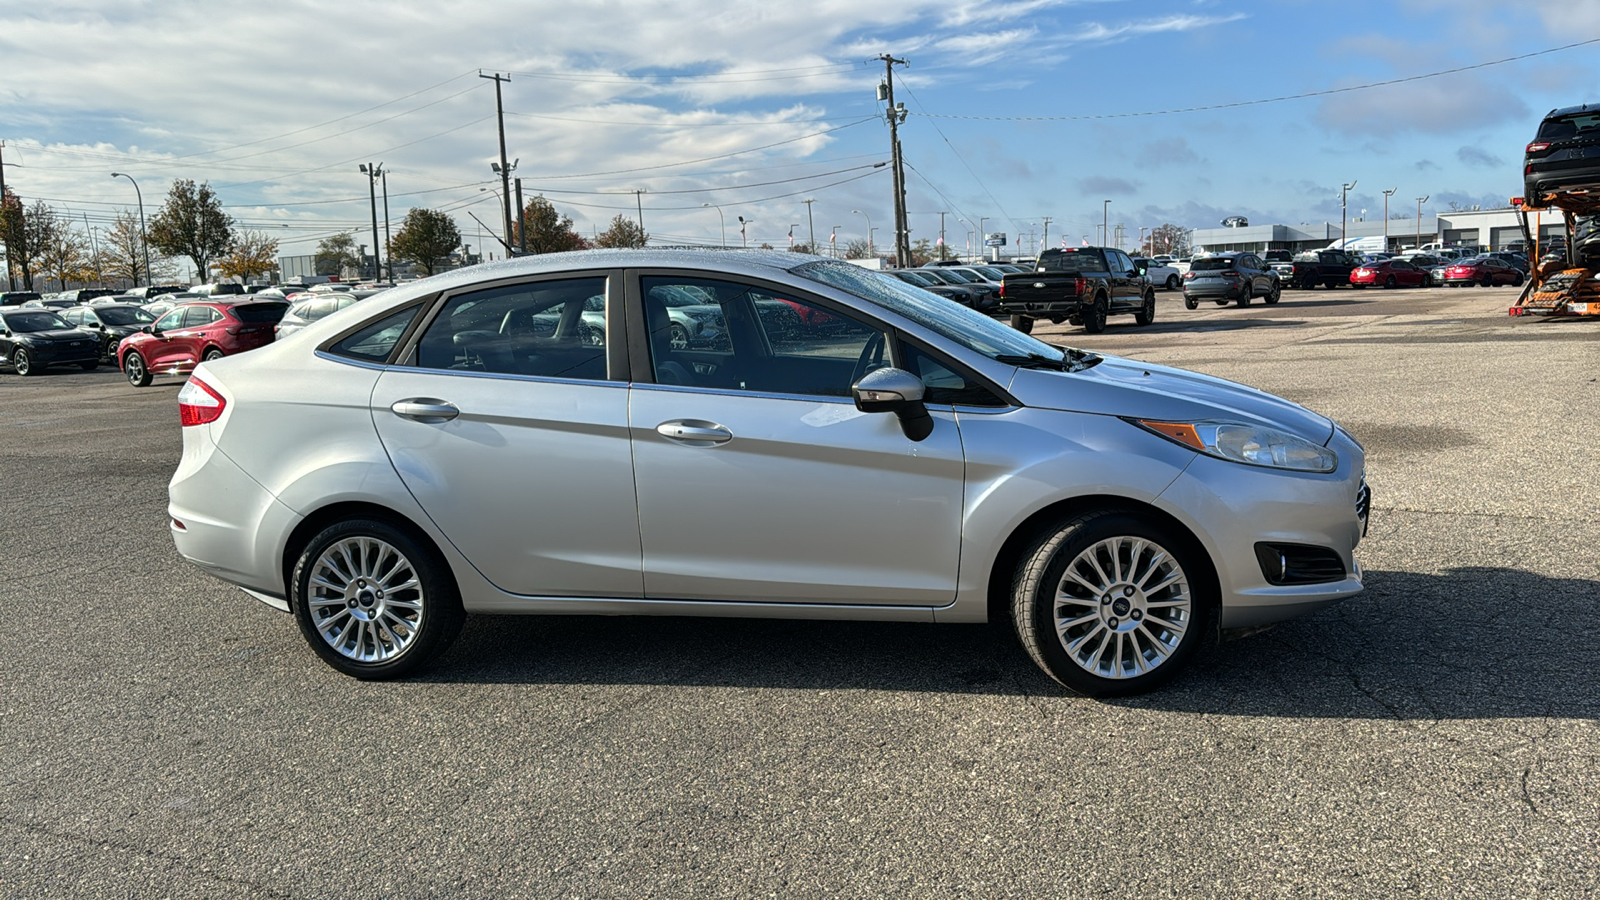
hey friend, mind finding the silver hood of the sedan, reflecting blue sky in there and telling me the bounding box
[1011,356,1333,445]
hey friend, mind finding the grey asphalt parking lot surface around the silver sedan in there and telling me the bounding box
[0,288,1600,898]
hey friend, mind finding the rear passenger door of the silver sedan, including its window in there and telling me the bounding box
[371,271,643,599]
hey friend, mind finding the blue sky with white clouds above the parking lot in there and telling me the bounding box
[0,0,1600,255]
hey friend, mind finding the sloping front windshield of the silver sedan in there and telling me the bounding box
[792,259,1061,360]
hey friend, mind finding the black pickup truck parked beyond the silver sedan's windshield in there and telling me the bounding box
[995,247,1155,335]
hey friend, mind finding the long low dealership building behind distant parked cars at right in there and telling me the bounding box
[1189,207,1566,253]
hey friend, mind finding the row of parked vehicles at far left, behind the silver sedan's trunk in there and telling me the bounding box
[0,283,389,379]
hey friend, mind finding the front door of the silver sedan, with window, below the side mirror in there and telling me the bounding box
[629,272,965,607]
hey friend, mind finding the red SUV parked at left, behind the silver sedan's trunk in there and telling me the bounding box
[117,299,290,388]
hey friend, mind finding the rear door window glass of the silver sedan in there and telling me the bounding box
[416,275,606,380]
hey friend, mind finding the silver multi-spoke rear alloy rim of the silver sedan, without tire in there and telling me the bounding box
[307,536,426,663]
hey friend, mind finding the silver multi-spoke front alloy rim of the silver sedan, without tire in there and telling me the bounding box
[1053,536,1194,679]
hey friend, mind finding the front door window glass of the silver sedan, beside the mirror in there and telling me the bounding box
[640,275,888,397]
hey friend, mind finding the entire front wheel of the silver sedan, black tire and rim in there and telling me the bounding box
[1011,509,1218,697]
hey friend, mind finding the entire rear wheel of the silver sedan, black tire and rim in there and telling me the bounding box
[290,519,466,681]
